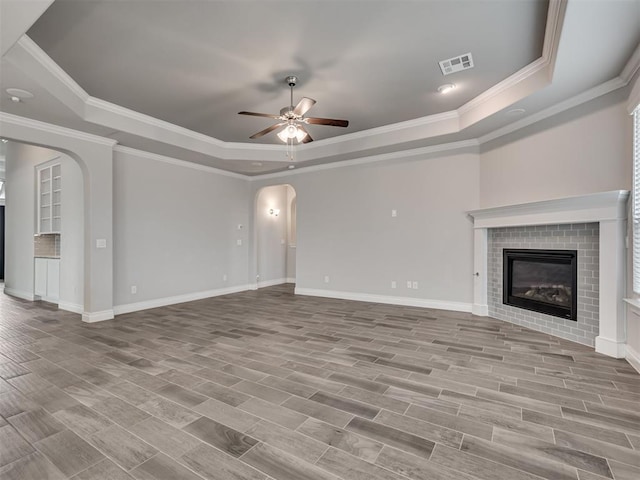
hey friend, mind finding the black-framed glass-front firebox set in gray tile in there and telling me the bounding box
[503,249,578,320]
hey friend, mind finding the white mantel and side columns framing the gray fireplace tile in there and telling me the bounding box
[468,190,629,358]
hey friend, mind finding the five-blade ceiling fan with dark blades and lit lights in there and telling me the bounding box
[238,75,349,143]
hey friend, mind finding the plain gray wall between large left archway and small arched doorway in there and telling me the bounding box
[113,151,249,306]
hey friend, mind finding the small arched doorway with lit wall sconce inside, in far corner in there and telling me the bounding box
[254,184,297,288]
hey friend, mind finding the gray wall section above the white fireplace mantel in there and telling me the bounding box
[480,90,633,207]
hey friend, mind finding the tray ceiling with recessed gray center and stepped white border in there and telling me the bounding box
[0,0,640,174]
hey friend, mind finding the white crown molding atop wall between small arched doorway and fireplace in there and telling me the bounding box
[248,139,480,182]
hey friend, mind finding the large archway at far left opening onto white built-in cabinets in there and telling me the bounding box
[5,141,85,313]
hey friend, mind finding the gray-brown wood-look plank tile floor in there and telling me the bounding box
[0,285,640,480]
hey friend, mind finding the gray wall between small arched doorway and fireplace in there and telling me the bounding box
[254,153,479,308]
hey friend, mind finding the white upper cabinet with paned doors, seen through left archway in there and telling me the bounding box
[37,163,62,233]
